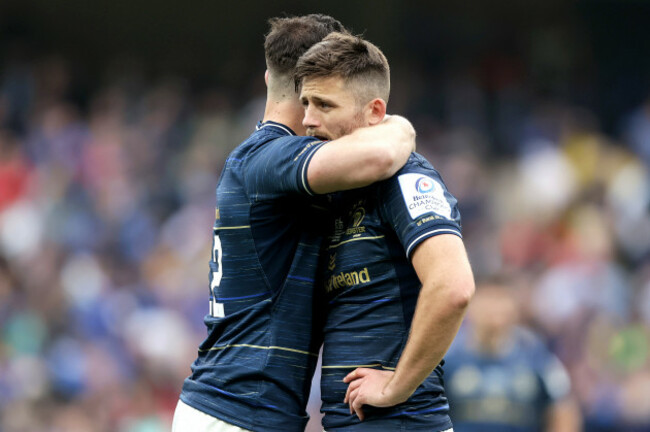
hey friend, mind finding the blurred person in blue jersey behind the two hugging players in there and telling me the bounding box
[445,283,581,432]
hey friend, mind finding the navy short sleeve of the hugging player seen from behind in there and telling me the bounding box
[242,136,324,198]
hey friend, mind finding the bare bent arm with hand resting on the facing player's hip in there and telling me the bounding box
[343,234,474,420]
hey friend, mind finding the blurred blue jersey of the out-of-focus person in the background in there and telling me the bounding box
[445,329,570,432]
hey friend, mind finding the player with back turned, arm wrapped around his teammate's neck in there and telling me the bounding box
[170,15,415,432]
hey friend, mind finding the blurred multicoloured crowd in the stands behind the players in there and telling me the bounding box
[0,44,650,432]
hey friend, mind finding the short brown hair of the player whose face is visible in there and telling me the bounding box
[294,33,390,103]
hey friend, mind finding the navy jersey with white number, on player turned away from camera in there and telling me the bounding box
[181,122,323,432]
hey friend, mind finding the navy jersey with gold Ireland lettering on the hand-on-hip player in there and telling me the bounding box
[321,153,460,432]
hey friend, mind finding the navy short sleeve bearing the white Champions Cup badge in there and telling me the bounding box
[380,154,462,258]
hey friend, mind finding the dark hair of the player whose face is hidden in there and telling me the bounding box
[264,14,347,75]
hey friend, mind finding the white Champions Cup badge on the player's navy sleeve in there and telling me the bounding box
[398,173,451,219]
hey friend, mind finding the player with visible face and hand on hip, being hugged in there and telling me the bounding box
[295,33,474,432]
